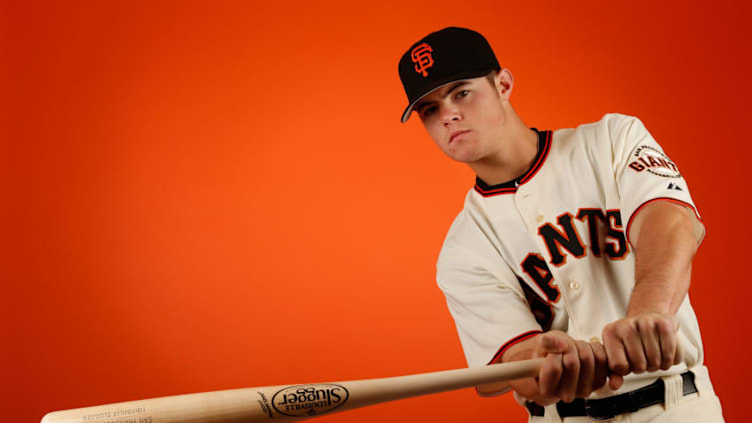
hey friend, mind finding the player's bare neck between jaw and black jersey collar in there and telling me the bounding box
[470,119,538,185]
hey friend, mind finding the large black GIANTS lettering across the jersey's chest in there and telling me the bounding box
[521,208,629,303]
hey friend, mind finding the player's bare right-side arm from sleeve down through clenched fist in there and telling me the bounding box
[603,201,698,389]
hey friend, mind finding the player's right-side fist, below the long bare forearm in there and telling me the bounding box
[603,313,679,390]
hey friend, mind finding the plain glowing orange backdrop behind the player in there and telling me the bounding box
[0,0,752,422]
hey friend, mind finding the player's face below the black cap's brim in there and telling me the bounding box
[415,73,505,163]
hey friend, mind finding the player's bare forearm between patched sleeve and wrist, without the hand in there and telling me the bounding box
[627,201,697,316]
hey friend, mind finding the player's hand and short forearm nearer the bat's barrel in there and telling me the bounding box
[499,331,608,405]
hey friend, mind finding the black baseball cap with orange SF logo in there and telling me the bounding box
[399,27,501,123]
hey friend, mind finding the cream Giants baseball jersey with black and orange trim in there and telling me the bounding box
[437,114,704,397]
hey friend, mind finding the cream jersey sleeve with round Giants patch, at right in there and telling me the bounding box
[604,114,705,245]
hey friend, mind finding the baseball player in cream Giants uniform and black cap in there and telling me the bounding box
[399,28,723,423]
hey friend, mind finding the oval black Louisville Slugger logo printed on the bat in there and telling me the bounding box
[272,383,349,417]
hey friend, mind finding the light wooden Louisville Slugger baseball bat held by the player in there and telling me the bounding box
[42,358,544,423]
